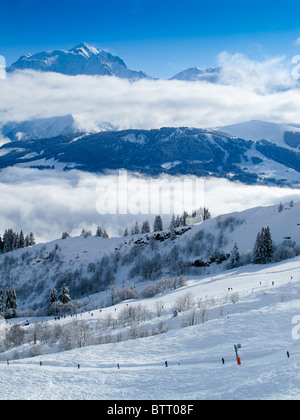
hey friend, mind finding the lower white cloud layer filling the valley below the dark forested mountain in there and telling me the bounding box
[0,167,300,242]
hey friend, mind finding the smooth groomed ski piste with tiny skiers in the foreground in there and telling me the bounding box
[0,257,300,400]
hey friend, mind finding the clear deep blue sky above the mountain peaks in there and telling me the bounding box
[0,0,300,77]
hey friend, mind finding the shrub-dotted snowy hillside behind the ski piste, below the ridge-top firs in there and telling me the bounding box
[0,203,300,311]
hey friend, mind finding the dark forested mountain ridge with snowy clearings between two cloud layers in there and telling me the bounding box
[0,121,300,187]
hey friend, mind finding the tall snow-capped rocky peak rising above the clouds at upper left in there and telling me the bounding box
[7,43,150,81]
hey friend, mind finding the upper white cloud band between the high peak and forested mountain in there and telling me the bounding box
[0,52,300,133]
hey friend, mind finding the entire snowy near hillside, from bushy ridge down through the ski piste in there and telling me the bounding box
[0,203,300,401]
